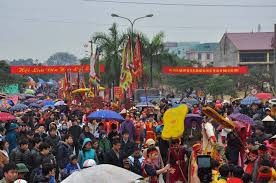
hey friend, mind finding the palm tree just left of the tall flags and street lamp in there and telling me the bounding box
[93,23,127,87]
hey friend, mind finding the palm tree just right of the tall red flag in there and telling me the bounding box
[141,32,165,87]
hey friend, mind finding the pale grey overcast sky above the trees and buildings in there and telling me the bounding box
[0,0,276,62]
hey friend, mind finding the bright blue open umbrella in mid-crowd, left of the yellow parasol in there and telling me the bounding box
[88,110,125,121]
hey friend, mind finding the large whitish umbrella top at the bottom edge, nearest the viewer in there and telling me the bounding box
[62,164,142,183]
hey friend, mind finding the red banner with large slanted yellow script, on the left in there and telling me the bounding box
[10,64,105,75]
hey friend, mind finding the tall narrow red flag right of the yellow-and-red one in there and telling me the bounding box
[132,36,143,78]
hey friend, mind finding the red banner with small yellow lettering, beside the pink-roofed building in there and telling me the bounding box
[163,66,248,75]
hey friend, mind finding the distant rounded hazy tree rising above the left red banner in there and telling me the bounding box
[46,52,78,65]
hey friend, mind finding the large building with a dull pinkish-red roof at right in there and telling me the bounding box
[214,32,274,71]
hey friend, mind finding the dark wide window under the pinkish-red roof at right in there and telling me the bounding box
[240,52,267,62]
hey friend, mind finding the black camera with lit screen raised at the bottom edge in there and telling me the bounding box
[197,155,212,183]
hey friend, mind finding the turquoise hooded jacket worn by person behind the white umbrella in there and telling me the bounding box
[79,138,97,168]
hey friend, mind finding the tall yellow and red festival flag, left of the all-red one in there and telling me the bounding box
[120,39,132,91]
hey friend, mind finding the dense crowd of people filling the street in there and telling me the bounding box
[0,93,276,183]
